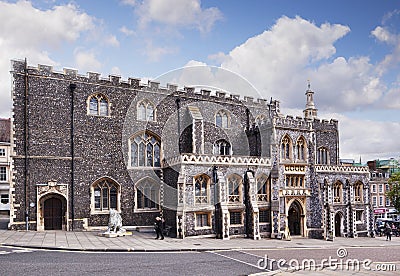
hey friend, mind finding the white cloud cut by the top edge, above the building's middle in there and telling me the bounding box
[136,0,222,32]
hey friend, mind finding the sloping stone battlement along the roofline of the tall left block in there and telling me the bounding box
[12,60,279,110]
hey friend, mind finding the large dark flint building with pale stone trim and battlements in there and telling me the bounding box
[10,61,373,239]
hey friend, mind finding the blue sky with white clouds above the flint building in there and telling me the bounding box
[0,0,400,162]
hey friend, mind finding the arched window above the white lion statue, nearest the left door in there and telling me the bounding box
[91,178,120,211]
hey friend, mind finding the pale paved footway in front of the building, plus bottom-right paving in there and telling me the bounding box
[0,216,400,275]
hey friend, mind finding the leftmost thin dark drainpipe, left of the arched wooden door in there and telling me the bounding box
[24,58,29,231]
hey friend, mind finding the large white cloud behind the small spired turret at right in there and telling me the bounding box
[211,16,385,111]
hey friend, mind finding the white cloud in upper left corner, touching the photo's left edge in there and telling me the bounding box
[0,1,94,117]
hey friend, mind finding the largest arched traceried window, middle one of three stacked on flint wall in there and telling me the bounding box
[130,132,161,167]
